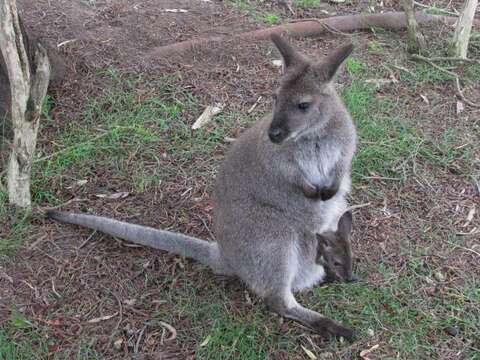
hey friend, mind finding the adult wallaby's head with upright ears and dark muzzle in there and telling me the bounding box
[268,34,353,144]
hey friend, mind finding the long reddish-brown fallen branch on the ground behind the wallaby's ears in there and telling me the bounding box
[150,12,480,57]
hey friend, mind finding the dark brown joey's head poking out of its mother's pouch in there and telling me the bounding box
[317,211,358,282]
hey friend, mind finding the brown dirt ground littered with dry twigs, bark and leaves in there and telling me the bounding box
[0,0,480,359]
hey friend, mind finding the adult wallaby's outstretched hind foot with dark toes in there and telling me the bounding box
[265,292,354,341]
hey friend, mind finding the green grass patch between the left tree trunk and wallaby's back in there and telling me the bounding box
[32,71,231,204]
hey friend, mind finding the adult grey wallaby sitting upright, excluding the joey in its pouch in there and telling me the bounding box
[48,35,356,339]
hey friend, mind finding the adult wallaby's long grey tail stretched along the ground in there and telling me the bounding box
[46,211,222,270]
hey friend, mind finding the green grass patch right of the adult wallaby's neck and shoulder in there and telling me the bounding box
[342,79,475,182]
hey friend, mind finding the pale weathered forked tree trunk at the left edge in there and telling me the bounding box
[0,0,50,208]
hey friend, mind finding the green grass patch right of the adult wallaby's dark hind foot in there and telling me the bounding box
[308,258,480,359]
